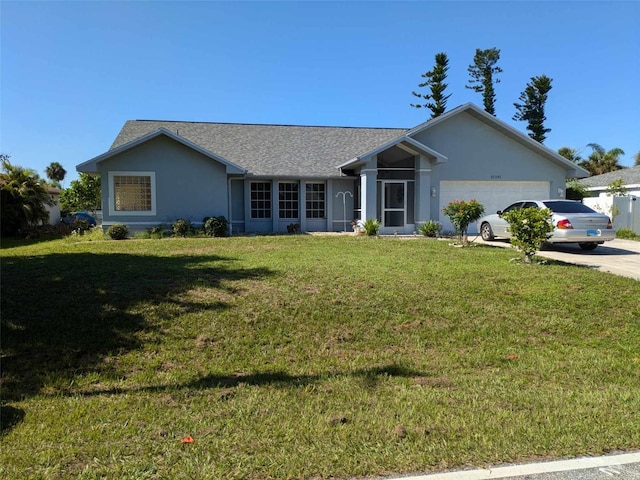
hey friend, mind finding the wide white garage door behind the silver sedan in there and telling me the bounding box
[440,181,549,233]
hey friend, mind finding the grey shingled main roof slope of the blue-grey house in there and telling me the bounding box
[110,120,408,177]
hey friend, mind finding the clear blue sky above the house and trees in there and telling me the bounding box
[0,0,640,185]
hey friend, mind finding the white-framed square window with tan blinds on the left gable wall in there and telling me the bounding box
[109,172,156,215]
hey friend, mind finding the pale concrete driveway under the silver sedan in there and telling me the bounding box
[475,237,640,280]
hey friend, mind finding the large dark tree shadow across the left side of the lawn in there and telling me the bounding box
[1,253,272,432]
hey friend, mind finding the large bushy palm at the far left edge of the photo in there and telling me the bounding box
[0,154,53,236]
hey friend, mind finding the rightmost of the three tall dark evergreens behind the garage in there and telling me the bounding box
[513,73,553,143]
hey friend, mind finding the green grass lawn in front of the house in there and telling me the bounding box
[0,236,640,479]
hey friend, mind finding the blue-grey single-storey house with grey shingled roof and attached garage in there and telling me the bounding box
[76,103,588,234]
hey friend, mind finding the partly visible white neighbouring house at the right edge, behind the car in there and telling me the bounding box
[578,165,640,234]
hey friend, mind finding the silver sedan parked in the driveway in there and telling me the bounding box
[478,200,616,250]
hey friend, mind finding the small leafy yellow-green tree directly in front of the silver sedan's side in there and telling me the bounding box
[502,207,554,263]
